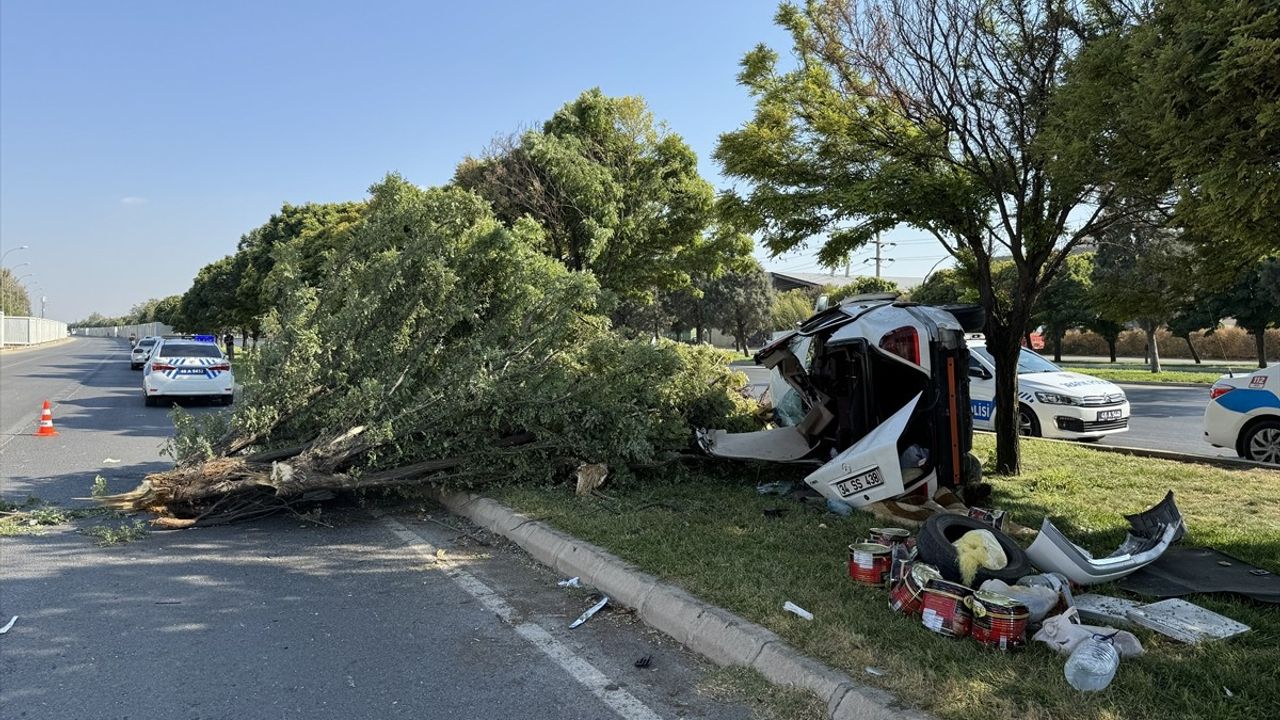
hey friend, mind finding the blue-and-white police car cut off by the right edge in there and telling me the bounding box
[1204,365,1280,465]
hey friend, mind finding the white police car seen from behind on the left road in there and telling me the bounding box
[142,336,236,405]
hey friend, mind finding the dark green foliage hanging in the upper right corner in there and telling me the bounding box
[1073,0,1280,282]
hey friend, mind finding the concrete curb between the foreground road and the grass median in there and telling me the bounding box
[430,488,933,720]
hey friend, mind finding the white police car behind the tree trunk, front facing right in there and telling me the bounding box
[966,334,1129,439]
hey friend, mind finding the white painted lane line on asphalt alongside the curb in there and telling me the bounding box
[374,511,660,720]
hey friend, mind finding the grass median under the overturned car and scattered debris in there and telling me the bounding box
[495,437,1280,720]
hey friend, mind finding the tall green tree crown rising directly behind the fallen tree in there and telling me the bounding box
[454,88,750,300]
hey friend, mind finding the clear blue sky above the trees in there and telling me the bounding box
[0,0,942,320]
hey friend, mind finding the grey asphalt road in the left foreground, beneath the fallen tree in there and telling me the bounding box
[0,338,750,720]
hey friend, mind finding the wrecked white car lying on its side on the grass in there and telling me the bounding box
[699,296,983,506]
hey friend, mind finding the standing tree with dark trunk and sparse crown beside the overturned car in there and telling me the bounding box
[716,0,1126,473]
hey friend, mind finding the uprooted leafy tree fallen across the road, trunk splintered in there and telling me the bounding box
[108,176,753,524]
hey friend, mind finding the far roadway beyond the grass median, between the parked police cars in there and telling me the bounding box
[735,365,1235,457]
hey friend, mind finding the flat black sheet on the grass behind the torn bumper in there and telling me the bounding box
[1120,547,1280,605]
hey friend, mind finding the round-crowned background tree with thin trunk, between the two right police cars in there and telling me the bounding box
[1092,203,1190,373]
